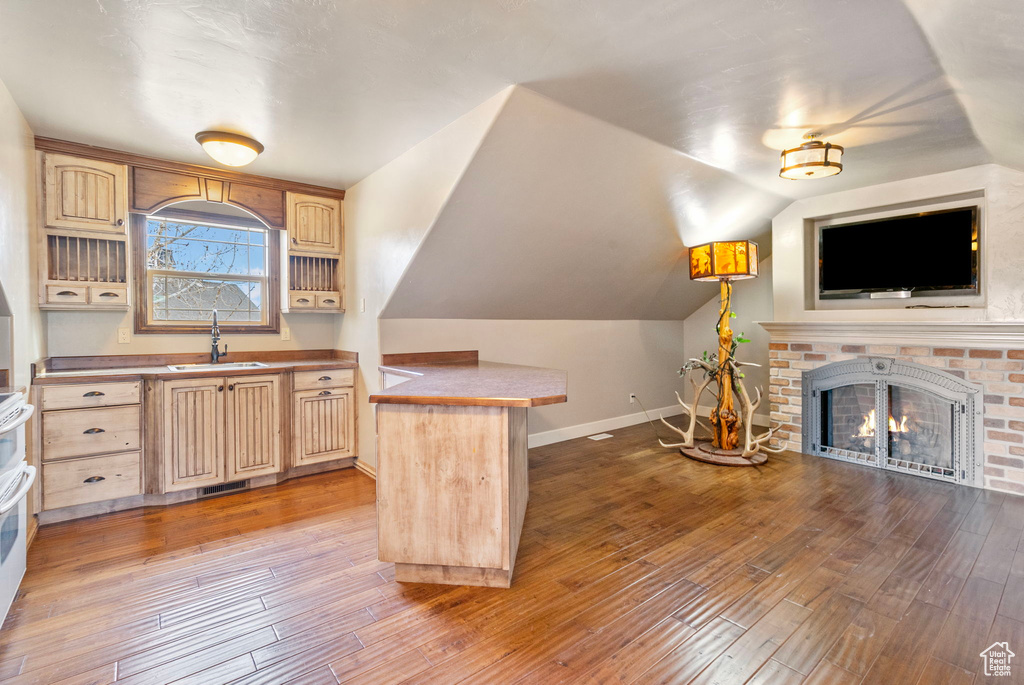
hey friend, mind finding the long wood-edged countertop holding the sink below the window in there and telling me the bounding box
[33,352,359,385]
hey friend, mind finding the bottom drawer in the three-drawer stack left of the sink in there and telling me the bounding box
[43,452,142,509]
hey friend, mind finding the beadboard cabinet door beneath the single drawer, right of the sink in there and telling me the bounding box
[292,388,355,466]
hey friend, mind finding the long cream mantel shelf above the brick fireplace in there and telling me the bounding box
[758,320,1024,348]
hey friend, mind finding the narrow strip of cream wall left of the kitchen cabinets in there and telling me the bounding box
[0,78,45,385]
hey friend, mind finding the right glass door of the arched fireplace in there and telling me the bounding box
[888,385,954,475]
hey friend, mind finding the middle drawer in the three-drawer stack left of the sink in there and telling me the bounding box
[43,404,141,462]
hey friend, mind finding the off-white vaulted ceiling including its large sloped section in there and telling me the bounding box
[0,0,1024,318]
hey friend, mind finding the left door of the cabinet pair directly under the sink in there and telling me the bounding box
[163,378,225,493]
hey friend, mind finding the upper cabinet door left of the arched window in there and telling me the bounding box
[43,154,128,234]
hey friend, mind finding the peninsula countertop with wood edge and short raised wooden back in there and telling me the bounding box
[370,352,567,406]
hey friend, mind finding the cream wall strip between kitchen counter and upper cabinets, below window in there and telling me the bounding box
[46,311,338,356]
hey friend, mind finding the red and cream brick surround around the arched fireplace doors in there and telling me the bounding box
[768,341,1024,495]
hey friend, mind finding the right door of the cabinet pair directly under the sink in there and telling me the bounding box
[224,376,281,480]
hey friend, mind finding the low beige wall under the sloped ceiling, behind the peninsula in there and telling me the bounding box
[380,318,686,439]
